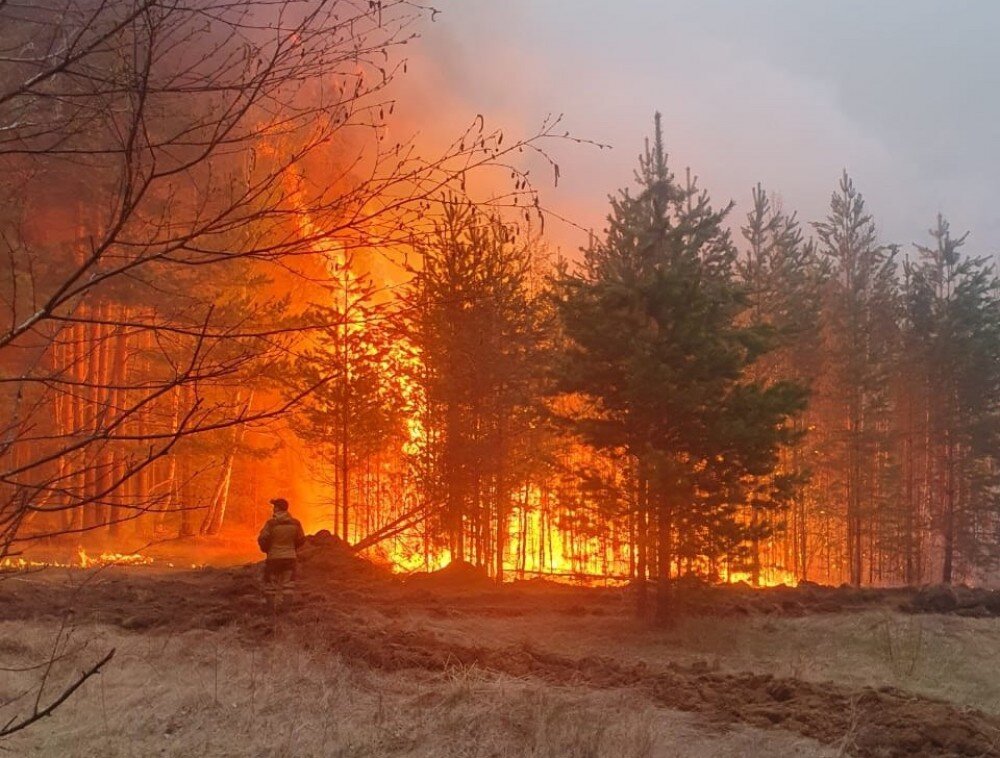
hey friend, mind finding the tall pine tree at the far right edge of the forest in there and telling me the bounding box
[907,216,1000,583]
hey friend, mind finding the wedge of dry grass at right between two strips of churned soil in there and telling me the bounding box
[400,610,1000,713]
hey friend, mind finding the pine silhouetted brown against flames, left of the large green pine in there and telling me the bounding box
[403,198,541,581]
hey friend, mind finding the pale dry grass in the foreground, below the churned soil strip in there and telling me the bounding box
[0,622,835,758]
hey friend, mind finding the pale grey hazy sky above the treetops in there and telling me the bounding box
[401,0,1000,254]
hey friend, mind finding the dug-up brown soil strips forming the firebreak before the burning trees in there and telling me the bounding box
[0,538,1000,756]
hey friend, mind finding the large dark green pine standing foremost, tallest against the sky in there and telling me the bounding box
[557,115,804,620]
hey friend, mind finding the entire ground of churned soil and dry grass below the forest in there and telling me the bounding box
[0,545,1000,756]
